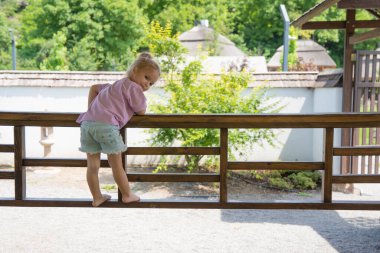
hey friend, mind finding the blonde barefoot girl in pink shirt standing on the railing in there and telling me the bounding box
[77,53,161,207]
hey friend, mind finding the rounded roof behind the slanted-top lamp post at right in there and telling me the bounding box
[268,40,336,68]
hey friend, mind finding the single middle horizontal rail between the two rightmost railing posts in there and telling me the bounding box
[228,162,324,170]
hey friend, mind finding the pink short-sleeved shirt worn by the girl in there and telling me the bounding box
[76,77,146,129]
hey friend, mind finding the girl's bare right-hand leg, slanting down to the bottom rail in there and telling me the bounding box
[108,153,140,203]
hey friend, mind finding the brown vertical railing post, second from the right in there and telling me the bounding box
[219,128,228,203]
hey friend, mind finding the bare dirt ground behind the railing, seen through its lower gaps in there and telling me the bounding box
[0,167,373,204]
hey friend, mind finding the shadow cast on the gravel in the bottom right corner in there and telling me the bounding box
[221,209,380,252]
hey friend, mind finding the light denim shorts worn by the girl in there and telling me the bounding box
[79,121,127,154]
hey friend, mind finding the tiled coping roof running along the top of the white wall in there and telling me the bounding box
[0,70,342,88]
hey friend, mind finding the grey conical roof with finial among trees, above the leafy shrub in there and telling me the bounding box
[179,25,245,56]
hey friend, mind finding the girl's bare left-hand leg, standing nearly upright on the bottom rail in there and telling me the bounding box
[87,154,111,206]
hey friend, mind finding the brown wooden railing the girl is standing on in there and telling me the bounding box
[0,112,380,210]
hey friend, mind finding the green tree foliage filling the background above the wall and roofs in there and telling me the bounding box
[0,0,377,70]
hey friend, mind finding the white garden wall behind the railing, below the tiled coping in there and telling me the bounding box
[0,87,342,168]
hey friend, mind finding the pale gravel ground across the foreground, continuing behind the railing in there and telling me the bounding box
[0,167,380,253]
